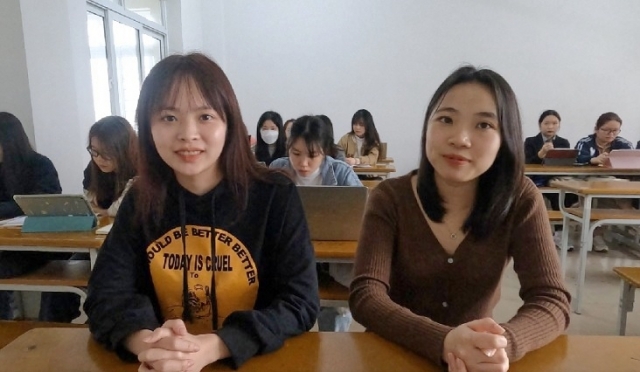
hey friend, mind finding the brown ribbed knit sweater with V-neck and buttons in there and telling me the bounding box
[349,171,570,364]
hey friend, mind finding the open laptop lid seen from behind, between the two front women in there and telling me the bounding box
[298,186,367,240]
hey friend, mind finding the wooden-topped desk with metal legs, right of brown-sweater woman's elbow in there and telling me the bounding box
[550,180,640,314]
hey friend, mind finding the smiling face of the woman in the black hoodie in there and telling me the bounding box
[151,81,227,191]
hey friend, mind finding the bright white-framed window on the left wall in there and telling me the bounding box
[87,0,167,124]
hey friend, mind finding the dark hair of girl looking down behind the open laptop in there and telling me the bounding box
[287,115,335,157]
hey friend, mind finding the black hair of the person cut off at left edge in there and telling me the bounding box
[0,112,35,196]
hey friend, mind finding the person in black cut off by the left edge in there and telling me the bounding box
[0,112,63,319]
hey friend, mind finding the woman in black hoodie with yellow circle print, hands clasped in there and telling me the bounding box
[85,53,319,371]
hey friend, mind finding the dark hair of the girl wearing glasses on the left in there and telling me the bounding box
[88,116,138,204]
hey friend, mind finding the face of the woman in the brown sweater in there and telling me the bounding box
[425,83,501,184]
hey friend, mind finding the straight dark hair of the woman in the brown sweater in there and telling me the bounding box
[418,66,524,238]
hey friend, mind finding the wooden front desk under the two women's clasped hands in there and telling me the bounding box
[0,324,640,372]
